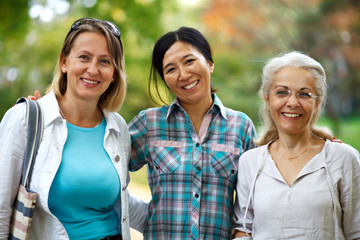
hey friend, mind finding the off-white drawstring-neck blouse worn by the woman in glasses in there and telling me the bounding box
[234,141,360,240]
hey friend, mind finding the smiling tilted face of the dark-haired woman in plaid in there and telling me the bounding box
[163,41,214,107]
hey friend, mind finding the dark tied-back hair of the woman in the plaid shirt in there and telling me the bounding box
[148,27,216,104]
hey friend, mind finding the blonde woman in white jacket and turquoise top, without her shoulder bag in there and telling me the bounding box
[0,18,147,240]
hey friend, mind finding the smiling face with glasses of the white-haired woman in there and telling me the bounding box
[265,67,320,134]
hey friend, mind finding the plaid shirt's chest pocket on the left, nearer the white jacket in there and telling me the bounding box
[149,141,183,174]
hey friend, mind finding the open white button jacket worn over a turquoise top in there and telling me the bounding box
[0,92,148,240]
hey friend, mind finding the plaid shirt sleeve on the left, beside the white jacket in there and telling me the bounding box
[129,111,147,171]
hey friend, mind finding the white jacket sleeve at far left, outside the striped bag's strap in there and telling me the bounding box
[0,104,27,239]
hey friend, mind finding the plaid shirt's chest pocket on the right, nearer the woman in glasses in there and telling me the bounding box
[211,144,240,178]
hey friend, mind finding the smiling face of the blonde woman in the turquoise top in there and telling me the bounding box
[61,32,115,101]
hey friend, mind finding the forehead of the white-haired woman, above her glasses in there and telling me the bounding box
[272,67,315,89]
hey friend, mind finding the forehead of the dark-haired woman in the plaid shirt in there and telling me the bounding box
[163,41,203,65]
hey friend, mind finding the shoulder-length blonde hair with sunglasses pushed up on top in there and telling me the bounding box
[47,21,126,112]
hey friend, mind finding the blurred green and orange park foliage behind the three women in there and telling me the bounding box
[0,0,360,239]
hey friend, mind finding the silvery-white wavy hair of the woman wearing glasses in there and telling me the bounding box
[256,51,333,146]
